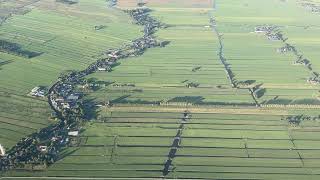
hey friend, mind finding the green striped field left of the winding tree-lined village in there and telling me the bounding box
[0,0,140,148]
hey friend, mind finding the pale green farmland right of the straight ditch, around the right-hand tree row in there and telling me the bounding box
[213,1,319,105]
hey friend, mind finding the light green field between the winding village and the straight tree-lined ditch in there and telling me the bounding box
[89,2,254,105]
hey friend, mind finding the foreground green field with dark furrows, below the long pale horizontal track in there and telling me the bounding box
[3,110,320,179]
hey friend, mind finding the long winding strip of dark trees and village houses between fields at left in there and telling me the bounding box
[0,3,168,171]
